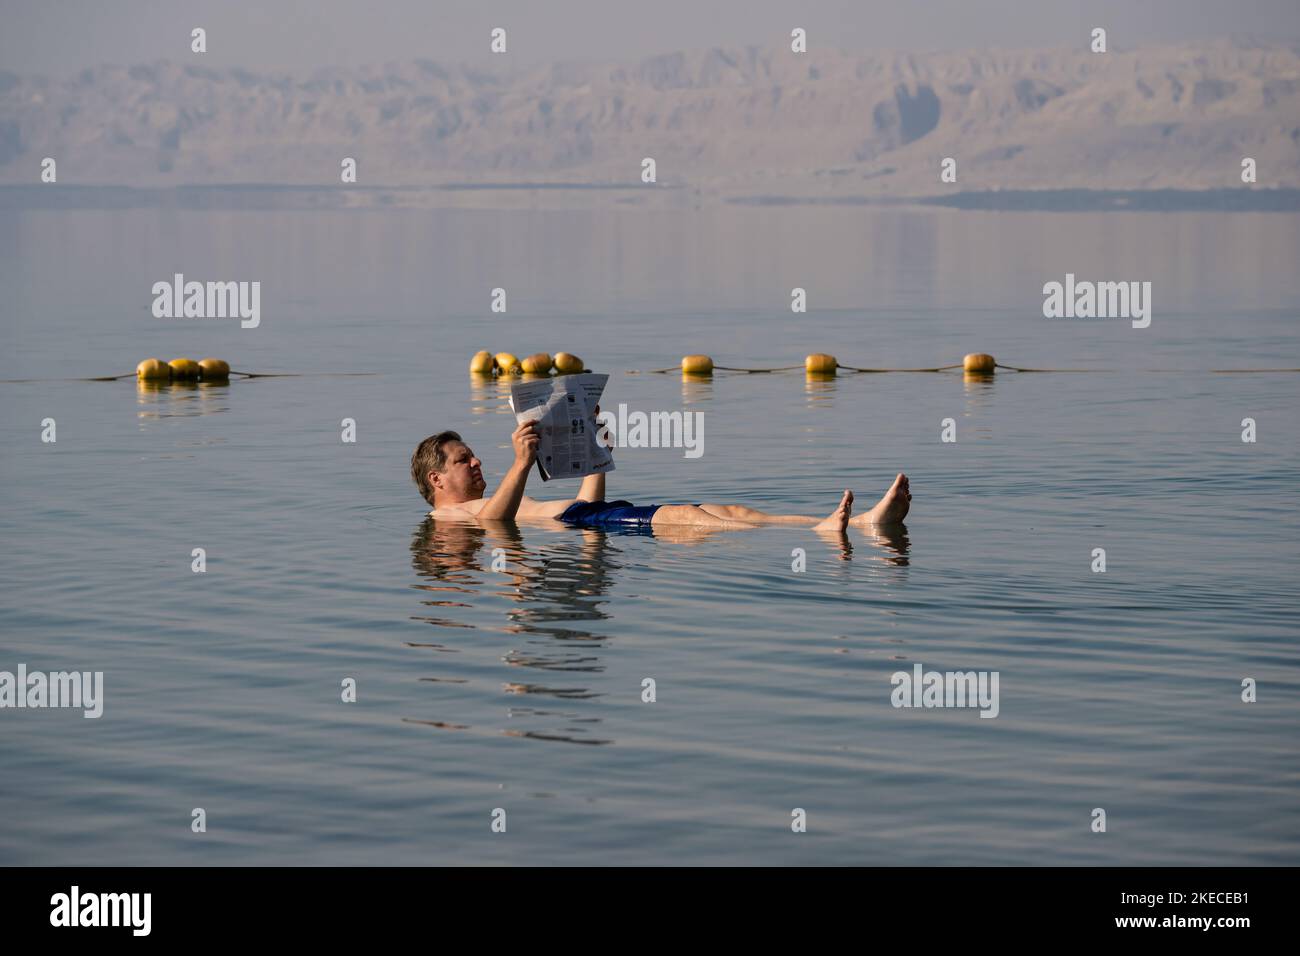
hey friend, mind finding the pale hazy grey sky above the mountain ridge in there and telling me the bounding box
[0,0,1300,77]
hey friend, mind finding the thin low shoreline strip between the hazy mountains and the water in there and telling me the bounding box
[0,182,1300,212]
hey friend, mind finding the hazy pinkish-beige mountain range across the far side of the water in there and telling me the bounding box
[0,40,1300,203]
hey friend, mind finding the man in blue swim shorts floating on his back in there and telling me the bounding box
[411,410,911,532]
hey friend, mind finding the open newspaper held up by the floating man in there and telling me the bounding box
[510,372,614,481]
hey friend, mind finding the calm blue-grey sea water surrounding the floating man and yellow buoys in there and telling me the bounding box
[0,208,1300,865]
